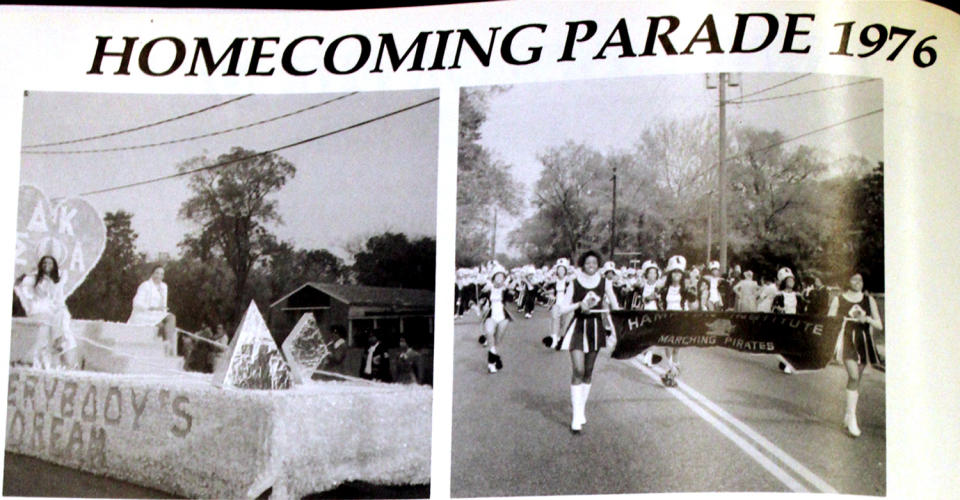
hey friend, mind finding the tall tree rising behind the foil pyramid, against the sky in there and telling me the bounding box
[178,147,296,315]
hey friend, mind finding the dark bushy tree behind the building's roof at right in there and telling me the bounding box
[352,232,437,290]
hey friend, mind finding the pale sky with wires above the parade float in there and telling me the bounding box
[20,90,438,258]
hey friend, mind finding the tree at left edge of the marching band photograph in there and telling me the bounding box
[456,90,523,266]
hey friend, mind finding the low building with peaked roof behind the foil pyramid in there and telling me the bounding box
[270,282,435,348]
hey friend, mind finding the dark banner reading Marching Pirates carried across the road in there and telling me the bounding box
[610,311,843,370]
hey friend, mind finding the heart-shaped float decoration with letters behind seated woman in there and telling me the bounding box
[14,185,107,296]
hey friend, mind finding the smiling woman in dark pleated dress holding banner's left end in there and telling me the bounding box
[560,250,620,434]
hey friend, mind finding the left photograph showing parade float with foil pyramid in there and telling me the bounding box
[3,89,439,498]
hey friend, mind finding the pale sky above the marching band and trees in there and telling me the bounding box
[472,73,883,255]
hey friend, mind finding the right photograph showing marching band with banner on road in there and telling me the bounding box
[451,72,887,497]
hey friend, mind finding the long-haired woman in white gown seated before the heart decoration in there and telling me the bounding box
[14,255,77,368]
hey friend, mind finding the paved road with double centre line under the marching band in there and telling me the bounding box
[451,310,886,497]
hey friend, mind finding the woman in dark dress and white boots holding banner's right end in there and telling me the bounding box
[827,273,883,437]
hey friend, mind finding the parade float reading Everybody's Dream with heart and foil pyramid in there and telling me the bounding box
[6,186,432,498]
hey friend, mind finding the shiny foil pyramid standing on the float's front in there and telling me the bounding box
[213,301,293,389]
